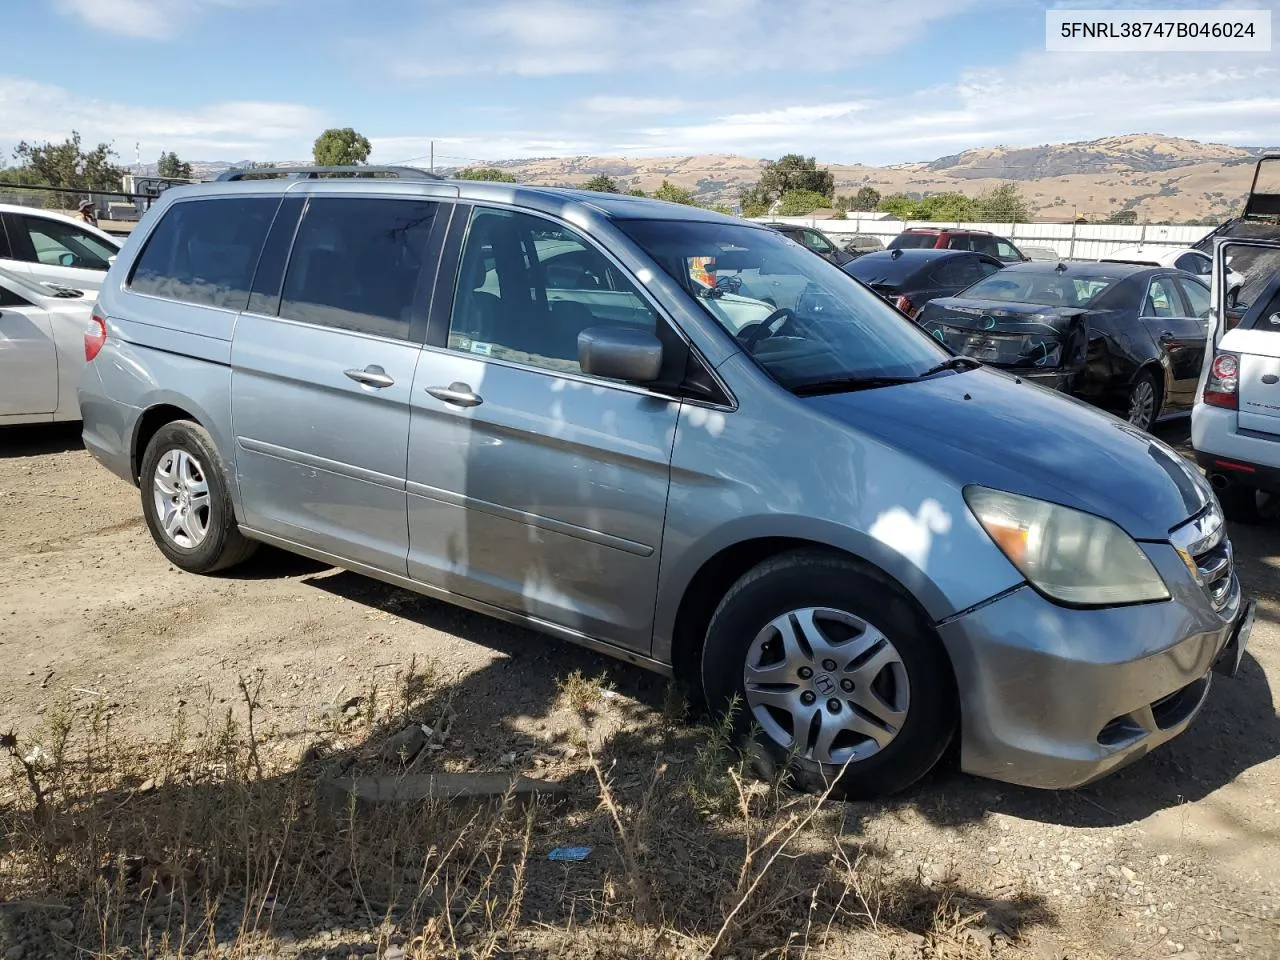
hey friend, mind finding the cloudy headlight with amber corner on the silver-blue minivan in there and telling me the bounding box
[964,486,1169,607]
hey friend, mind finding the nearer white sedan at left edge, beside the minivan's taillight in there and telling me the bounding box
[0,268,93,425]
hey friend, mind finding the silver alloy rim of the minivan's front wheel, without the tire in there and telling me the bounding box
[744,607,910,765]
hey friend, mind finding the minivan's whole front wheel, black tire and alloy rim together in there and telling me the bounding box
[701,550,959,800]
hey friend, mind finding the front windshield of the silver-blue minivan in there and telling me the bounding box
[617,220,950,389]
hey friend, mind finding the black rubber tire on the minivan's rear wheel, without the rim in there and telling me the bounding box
[138,420,236,573]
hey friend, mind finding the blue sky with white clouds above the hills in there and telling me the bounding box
[0,0,1280,165]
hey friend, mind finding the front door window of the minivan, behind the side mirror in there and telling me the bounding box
[448,207,655,374]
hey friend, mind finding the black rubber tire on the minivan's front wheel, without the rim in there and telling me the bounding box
[701,553,956,799]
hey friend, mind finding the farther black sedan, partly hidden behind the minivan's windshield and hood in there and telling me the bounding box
[840,250,1005,317]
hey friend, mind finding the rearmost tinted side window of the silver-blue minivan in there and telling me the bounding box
[129,197,280,310]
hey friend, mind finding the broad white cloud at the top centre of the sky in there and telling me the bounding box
[376,0,977,78]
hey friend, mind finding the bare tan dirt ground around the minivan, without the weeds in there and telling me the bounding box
[0,425,1280,960]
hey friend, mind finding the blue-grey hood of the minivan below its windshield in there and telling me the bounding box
[803,369,1212,540]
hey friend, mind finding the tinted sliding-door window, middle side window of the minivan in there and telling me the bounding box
[280,197,440,340]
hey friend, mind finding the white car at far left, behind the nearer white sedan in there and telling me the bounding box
[0,204,122,293]
